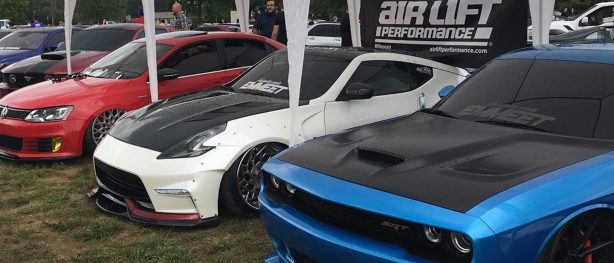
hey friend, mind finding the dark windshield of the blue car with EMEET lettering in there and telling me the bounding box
[438,60,614,139]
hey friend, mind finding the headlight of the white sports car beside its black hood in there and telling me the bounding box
[158,124,226,159]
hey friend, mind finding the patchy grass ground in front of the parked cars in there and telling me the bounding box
[0,158,273,262]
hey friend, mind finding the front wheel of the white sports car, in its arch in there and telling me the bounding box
[220,143,286,216]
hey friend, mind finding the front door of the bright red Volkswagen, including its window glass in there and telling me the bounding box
[158,40,229,99]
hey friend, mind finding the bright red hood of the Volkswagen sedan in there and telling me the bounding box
[0,78,131,109]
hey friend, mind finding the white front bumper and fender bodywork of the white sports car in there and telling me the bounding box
[94,104,324,219]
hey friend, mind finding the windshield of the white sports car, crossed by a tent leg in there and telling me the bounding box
[232,51,349,100]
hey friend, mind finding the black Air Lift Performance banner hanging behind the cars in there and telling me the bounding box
[361,0,529,68]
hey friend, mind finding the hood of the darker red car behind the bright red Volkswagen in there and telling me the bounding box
[2,51,109,75]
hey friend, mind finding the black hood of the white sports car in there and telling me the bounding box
[110,90,288,152]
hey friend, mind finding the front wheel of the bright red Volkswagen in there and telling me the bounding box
[83,109,126,155]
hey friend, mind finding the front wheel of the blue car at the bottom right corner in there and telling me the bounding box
[538,210,614,263]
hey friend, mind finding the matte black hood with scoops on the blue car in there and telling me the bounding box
[278,112,614,213]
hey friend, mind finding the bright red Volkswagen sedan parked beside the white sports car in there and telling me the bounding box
[0,31,285,160]
